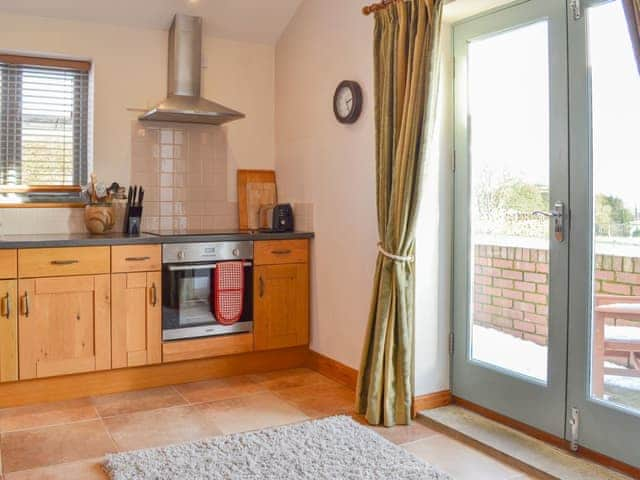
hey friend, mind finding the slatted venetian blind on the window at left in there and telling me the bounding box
[0,57,89,190]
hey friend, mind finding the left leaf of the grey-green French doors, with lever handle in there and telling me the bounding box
[453,0,569,436]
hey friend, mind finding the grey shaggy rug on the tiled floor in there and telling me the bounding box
[104,416,452,480]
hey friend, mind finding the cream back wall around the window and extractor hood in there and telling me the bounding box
[0,14,275,233]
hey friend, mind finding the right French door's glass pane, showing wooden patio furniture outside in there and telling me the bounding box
[587,0,640,412]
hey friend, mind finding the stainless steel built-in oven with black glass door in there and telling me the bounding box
[162,241,253,341]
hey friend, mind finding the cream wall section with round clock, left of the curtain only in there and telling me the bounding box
[276,0,377,368]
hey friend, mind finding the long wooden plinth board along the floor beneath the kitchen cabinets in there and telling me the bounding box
[0,346,309,408]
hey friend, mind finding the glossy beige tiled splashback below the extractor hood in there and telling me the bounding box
[131,122,238,230]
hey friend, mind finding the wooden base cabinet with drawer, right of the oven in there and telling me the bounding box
[253,240,309,350]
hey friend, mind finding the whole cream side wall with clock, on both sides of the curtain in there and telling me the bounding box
[276,0,450,395]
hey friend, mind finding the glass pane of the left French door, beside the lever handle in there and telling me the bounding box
[468,21,549,382]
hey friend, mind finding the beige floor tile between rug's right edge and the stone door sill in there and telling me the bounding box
[403,434,524,480]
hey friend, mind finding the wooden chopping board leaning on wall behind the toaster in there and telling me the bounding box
[237,170,278,230]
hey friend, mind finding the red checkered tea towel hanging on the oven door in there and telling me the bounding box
[214,262,244,325]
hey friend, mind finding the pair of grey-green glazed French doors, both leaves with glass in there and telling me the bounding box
[452,0,640,466]
